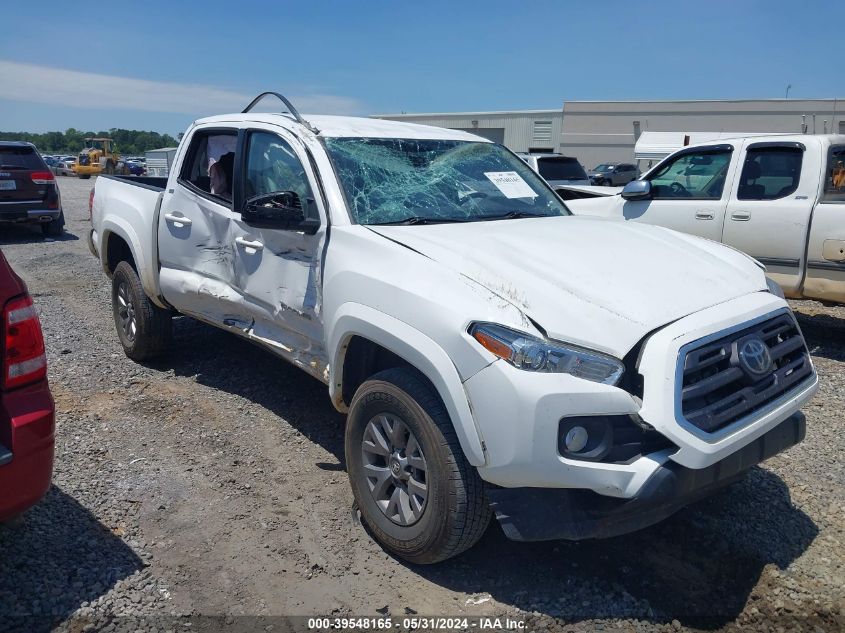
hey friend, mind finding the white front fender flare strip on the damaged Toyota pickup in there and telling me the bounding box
[326,303,486,466]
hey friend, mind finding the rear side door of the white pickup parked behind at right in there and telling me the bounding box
[722,141,821,295]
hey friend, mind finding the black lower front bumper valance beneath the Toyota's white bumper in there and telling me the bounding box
[487,412,806,541]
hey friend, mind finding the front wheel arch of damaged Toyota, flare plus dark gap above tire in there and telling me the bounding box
[328,303,486,466]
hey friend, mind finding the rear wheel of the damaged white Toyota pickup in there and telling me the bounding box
[112,261,173,361]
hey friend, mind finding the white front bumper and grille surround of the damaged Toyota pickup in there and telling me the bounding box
[464,292,818,499]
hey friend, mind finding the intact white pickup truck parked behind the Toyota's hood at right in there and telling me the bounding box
[565,134,845,303]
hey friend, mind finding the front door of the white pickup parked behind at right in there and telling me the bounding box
[622,145,737,242]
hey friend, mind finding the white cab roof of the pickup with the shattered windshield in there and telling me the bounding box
[191,112,490,143]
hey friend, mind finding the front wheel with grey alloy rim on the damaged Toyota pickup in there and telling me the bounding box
[345,367,492,564]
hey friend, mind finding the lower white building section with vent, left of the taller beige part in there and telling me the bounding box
[373,110,563,152]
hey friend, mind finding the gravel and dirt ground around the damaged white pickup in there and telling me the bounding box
[0,178,845,631]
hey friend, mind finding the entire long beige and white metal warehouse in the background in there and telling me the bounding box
[376,98,845,168]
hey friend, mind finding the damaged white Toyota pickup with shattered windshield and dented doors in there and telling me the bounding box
[89,93,817,563]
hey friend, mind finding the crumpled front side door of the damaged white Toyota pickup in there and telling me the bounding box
[232,129,328,380]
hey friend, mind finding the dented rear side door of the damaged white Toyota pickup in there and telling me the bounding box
[158,127,251,330]
